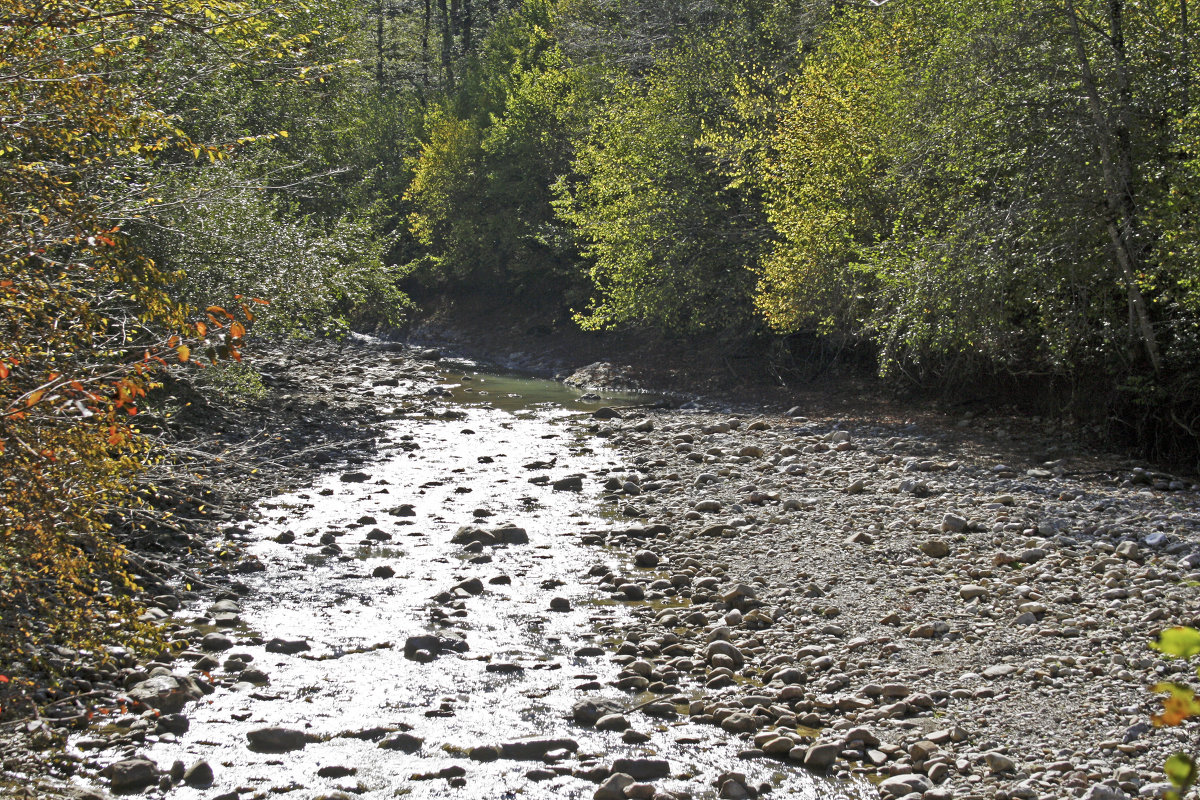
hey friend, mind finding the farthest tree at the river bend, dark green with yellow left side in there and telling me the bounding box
[406,0,574,291]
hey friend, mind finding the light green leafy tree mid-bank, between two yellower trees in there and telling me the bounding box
[558,41,763,331]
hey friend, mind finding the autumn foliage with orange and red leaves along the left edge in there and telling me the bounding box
[0,0,328,714]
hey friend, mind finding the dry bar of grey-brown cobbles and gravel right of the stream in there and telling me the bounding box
[566,409,1200,800]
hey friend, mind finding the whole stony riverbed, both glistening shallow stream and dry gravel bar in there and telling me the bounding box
[5,342,1200,800]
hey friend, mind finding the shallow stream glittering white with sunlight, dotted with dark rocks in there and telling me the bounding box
[96,371,871,800]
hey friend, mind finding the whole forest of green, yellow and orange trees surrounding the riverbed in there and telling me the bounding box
[0,0,1200,777]
